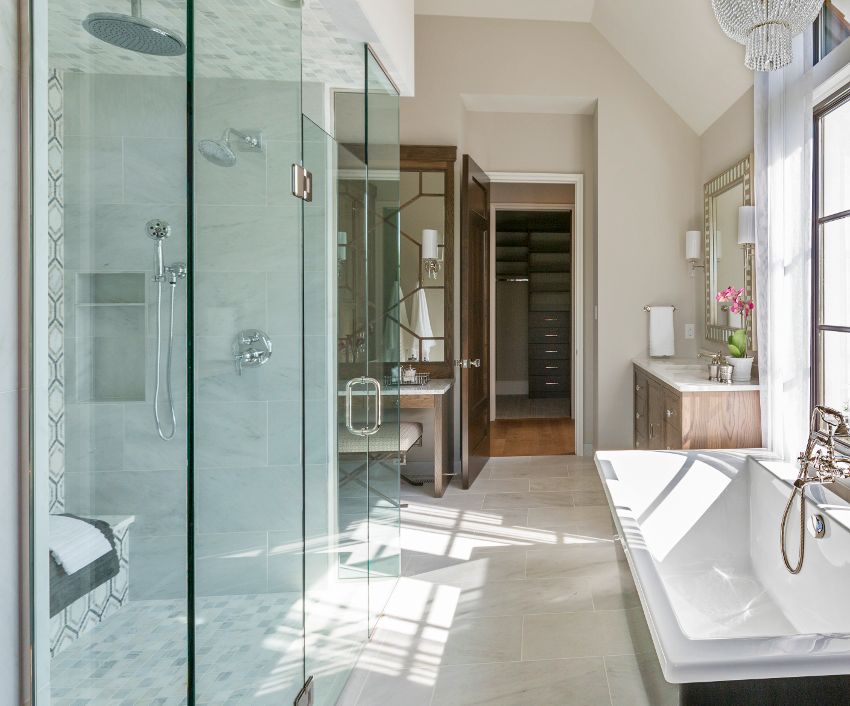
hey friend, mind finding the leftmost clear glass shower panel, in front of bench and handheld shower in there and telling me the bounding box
[33,0,188,704]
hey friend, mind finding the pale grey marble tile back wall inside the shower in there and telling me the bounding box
[65,73,316,599]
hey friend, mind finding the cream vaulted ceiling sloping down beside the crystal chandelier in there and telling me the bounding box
[416,0,753,135]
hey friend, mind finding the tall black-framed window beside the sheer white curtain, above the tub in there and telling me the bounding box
[812,86,850,415]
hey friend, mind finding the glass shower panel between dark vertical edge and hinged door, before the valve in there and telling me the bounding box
[192,0,304,705]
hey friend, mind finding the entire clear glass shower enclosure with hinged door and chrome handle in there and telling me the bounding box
[26,0,400,706]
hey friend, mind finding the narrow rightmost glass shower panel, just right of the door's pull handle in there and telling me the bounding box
[365,48,401,630]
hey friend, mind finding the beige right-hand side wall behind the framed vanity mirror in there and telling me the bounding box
[682,88,755,351]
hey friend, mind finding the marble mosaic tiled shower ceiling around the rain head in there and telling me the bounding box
[48,0,363,89]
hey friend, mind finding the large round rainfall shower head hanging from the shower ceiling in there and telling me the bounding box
[83,0,186,56]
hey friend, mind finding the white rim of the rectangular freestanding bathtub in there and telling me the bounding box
[594,449,850,684]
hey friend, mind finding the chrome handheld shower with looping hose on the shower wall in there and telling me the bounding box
[147,219,186,441]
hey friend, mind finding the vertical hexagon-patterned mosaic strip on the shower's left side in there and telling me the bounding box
[47,69,65,513]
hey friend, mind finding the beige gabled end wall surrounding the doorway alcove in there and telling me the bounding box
[401,16,699,448]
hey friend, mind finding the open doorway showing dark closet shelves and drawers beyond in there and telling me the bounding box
[491,205,576,456]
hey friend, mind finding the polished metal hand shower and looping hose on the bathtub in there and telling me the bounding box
[779,405,850,574]
